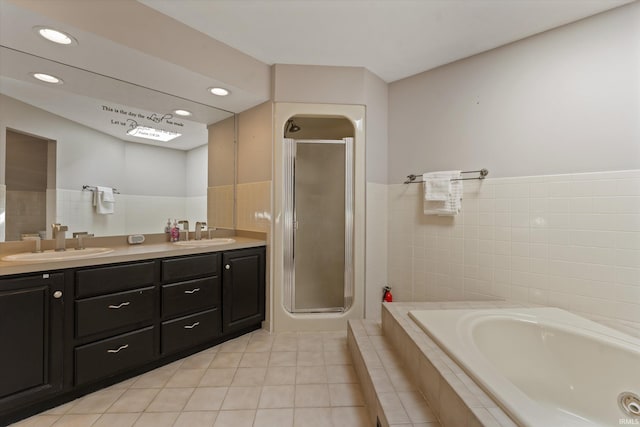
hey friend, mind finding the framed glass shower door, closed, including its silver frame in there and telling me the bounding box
[285,138,353,312]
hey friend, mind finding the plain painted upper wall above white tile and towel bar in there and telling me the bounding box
[389,2,640,183]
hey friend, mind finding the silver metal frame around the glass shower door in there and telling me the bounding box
[282,137,355,314]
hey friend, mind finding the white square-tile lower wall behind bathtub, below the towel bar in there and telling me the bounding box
[388,170,640,329]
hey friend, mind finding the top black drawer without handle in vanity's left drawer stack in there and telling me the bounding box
[76,261,155,298]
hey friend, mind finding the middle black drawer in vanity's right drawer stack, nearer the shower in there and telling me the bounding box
[162,276,220,317]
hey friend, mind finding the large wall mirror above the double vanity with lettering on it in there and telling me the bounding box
[0,47,235,241]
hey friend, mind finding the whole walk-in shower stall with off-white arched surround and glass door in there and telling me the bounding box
[268,102,366,332]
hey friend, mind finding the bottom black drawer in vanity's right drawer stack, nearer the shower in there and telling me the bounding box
[162,308,221,354]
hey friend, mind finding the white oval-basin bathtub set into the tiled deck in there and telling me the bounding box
[409,308,640,427]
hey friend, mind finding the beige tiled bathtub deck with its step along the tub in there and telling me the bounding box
[348,301,523,427]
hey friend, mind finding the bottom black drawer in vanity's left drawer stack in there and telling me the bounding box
[75,326,154,384]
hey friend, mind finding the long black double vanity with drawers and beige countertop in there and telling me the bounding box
[0,236,265,425]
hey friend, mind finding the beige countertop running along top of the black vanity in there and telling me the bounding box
[0,236,266,276]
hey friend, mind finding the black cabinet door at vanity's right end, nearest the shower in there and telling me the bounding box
[222,248,265,334]
